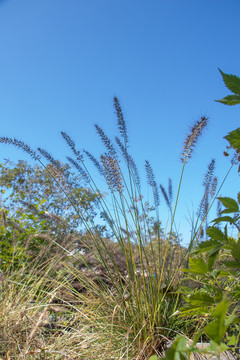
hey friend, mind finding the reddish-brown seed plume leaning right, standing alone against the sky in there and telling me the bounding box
[181,116,208,162]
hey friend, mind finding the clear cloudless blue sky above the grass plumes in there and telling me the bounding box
[0,0,240,242]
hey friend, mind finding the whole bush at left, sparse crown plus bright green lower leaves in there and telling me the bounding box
[0,161,101,271]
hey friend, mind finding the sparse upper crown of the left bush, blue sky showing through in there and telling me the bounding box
[0,161,97,232]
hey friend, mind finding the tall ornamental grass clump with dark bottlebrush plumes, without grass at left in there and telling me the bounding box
[0,98,217,360]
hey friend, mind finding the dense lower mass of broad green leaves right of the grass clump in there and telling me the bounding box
[176,191,240,350]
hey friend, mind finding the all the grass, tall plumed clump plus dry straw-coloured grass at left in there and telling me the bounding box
[0,98,232,360]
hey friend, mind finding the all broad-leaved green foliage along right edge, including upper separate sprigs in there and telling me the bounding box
[150,70,240,360]
